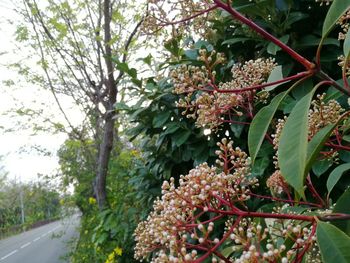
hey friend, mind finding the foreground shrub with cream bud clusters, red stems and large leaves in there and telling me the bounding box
[135,0,350,262]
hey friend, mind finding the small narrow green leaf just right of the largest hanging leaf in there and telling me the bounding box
[305,124,337,173]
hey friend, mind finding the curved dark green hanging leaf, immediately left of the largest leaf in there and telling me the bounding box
[248,91,288,163]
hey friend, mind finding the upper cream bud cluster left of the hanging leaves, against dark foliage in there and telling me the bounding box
[170,49,276,130]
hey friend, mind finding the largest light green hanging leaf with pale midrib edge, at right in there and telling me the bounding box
[278,83,317,197]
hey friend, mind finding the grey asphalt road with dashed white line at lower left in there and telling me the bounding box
[0,216,79,263]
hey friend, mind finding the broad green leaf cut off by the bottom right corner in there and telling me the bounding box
[316,221,350,263]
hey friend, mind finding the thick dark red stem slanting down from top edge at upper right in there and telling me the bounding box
[213,0,315,70]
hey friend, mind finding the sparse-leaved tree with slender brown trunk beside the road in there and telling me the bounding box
[16,0,143,208]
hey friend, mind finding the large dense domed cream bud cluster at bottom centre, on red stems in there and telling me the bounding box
[135,139,257,262]
